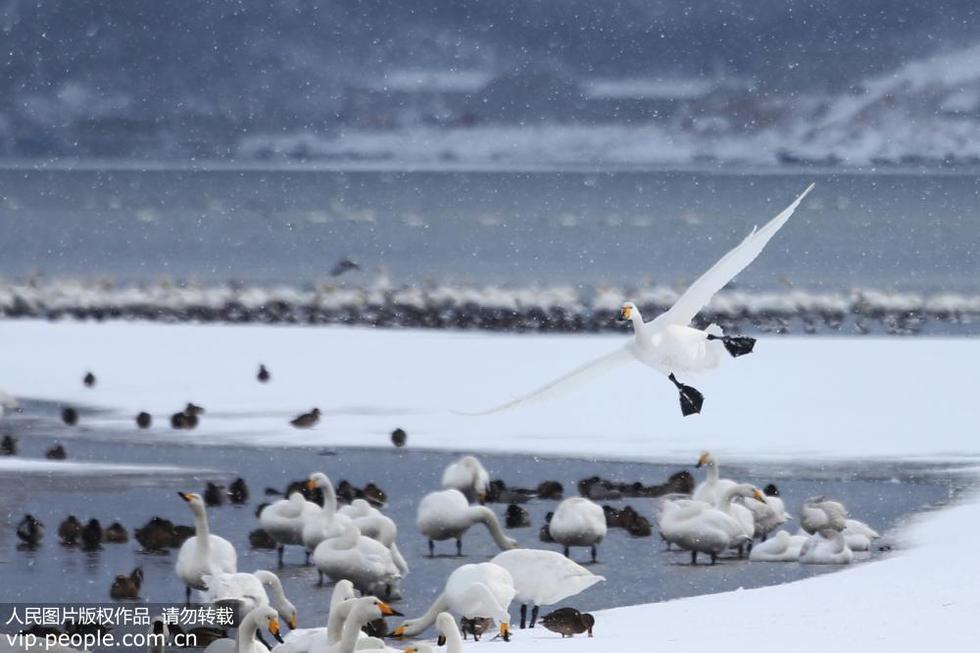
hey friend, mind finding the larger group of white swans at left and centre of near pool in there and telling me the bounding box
[176,456,606,653]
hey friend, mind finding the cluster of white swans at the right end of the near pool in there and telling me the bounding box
[657,452,880,564]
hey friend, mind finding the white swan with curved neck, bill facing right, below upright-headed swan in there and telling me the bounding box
[660,484,763,565]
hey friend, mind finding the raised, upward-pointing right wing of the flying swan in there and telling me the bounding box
[653,184,814,326]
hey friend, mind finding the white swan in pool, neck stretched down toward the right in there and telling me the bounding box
[415,489,516,556]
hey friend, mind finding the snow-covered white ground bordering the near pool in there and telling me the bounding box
[0,322,980,652]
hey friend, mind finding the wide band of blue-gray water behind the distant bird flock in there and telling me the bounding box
[0,167,980,293]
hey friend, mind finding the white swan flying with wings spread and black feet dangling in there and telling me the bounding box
[466,184,813,416]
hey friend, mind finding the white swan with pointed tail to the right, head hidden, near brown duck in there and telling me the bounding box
[490,549,606,628]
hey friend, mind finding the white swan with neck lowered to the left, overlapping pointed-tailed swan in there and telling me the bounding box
[393,562,517,640]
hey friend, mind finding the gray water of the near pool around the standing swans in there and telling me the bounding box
[0,408,955,640]
